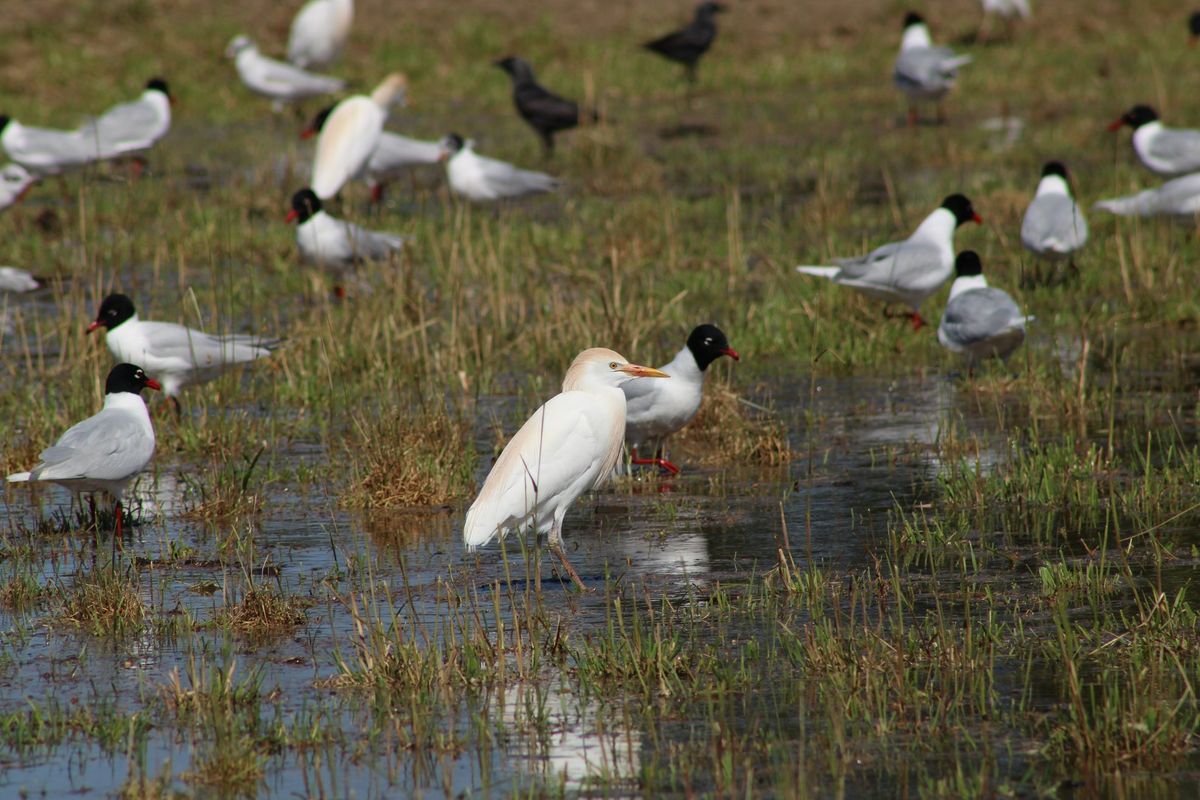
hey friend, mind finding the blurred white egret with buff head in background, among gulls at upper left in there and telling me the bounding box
[311,73,408,200]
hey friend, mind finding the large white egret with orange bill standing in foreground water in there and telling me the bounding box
[462,348,667,589]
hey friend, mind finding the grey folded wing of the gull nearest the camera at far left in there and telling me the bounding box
[30,409,154,481]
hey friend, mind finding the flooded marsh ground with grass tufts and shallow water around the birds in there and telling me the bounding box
[0,0,1200,798]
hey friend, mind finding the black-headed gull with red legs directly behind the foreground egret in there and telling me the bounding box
[622,325,740,475]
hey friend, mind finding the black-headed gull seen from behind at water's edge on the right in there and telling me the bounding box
[937,249,1033,369]
